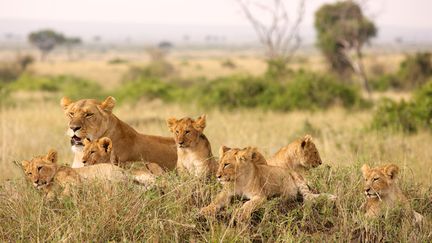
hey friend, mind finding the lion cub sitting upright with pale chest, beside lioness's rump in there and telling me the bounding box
[167,115,217,176]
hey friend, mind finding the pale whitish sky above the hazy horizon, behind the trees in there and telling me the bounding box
[0,0,432,43]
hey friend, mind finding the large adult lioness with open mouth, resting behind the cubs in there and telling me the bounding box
[61,96,177,169]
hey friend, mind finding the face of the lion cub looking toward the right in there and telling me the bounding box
[299,135,322,169]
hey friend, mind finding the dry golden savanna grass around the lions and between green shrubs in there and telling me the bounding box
[0,50,432,242]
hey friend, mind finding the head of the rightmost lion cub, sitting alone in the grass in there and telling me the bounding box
[361,164,399,198]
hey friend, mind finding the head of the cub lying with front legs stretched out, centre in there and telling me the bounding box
[216,146,266,184]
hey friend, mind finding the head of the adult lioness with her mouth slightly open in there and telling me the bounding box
[60,96,115,149]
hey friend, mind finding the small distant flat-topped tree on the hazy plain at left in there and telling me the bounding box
[28,29,65,61]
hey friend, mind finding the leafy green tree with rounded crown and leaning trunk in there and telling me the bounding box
[315,1,377,94]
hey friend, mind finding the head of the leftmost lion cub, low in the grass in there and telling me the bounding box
[21,150,58,189]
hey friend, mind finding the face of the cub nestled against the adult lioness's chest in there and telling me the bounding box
[82,137,112,166]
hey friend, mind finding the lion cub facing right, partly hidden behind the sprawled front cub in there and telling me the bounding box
[267,135,322,172]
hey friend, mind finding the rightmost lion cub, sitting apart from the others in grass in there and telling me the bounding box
[361,164,423,223]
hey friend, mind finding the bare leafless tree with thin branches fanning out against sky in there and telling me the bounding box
[237,0,305,77]
